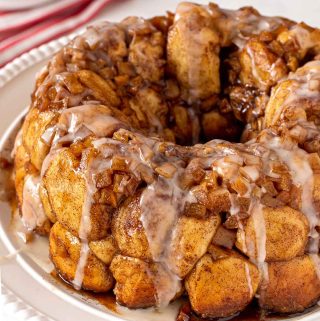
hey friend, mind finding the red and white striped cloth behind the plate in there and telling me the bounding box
[0,0,112,67]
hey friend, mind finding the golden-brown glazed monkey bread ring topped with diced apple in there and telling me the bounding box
[15,3,320,317]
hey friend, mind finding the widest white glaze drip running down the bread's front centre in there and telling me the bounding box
[140,177,196,307]
